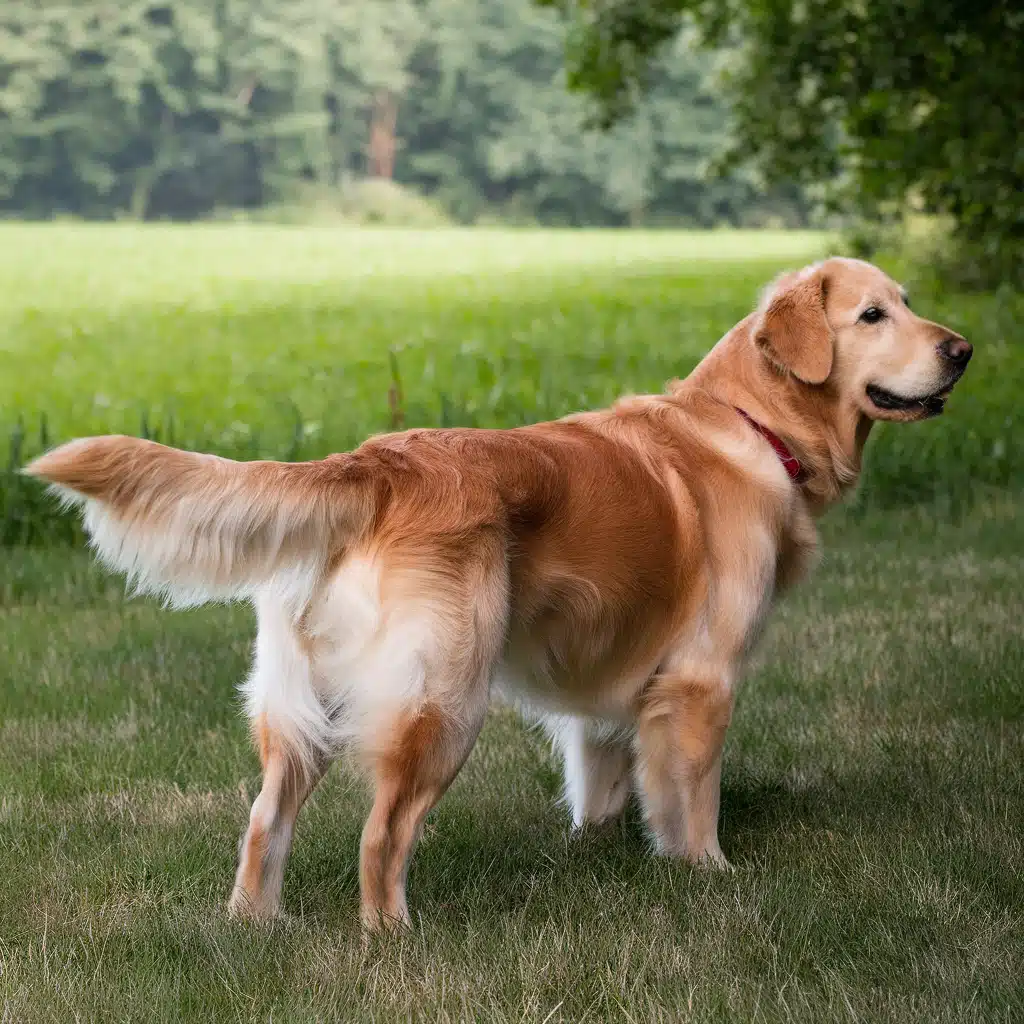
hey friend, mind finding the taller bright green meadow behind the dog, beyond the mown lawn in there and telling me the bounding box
[0,224,1024,543]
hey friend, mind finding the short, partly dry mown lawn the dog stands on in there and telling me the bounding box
[0,501,1024,1022]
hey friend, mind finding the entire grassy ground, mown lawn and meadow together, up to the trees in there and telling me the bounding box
[0,225,1024,1022]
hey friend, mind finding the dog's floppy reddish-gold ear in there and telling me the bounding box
[754,270,835,384]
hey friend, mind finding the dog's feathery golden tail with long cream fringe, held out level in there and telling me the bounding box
[25,435,373,606]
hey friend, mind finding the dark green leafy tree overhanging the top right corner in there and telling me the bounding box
[542,0,1024,275]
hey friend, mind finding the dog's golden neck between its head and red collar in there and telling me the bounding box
[675,314,871,513]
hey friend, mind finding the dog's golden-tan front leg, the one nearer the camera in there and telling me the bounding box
[636,674,733,867]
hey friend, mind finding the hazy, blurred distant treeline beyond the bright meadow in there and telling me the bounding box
[0,0,807,225]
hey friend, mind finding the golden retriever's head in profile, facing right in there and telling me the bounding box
[753,258,972,421]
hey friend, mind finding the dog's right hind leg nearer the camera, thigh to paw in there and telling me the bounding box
[359,536,508,929]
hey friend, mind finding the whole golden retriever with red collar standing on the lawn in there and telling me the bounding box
[27,258,972,929]
